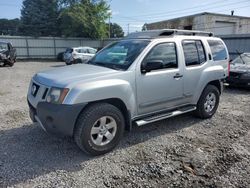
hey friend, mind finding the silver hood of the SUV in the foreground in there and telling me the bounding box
[33,64,118,87]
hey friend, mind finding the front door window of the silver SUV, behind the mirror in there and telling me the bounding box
[144,42,178,69]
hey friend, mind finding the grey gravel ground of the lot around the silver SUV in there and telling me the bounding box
[0,62,250,187]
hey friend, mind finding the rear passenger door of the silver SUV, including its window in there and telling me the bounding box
[182,39,207,101]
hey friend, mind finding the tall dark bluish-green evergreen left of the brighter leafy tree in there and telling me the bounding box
[19,0,58,36]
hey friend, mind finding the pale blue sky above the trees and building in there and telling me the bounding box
[0,0,250,33]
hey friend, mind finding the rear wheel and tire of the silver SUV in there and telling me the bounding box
[195,85,220,119]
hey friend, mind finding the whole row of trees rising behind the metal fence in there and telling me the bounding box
[5,0,124,39]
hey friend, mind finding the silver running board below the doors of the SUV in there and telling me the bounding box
[135,106,196,126]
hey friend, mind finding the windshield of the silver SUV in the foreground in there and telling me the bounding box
[88,40,150,70]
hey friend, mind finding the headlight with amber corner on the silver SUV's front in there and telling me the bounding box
[46,88,69,104]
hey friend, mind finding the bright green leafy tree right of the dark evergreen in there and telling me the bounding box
[60,0,109,39]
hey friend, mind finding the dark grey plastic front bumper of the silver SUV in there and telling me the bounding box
[29,102,87,136]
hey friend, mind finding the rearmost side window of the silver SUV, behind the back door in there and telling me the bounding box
[208,40,227,61]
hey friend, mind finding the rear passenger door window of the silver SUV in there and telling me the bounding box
[182,40,206,66]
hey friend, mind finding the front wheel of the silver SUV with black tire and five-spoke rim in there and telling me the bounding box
[74,103,125,156]
